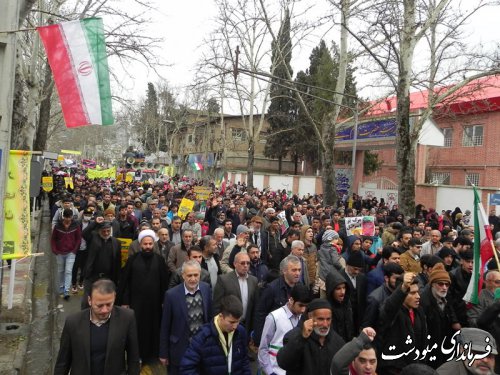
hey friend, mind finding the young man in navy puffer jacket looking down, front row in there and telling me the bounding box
[180,295,251,375]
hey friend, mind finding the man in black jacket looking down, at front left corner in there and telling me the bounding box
[54,279,140,375]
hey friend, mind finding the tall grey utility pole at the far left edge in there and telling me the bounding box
[0,0,22,309]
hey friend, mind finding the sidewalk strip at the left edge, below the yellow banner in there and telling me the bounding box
[0,210,42,375]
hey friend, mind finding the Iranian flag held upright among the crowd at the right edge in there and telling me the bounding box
[463,187,494,305]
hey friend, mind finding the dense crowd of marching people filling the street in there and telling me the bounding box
[49,169,500,375]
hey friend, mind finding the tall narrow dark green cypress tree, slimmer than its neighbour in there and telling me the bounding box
[264,10,296,174]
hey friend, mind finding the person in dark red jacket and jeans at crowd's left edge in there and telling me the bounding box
[50,208,82,301]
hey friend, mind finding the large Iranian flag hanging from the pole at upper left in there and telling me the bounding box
[37,18,113,128]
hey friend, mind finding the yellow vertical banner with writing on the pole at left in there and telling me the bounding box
[3,150,31,259]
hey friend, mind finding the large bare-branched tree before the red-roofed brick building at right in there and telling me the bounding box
[346,0,500,215]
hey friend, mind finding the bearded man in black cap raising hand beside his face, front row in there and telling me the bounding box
[278,298,345,375]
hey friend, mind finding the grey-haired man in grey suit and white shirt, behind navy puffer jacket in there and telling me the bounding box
[214,252,258,333]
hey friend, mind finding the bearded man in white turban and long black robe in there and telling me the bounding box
[119,229,168,363]
